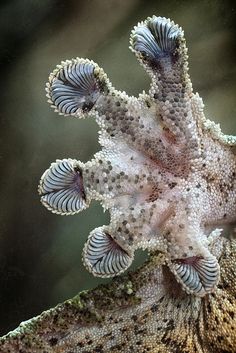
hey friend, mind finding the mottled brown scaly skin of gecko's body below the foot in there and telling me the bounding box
[0,238,236,353]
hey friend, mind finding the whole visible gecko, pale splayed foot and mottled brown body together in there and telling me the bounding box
[0,13,236,353]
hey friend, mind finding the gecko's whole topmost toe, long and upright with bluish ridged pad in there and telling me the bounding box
[130,16,201,155]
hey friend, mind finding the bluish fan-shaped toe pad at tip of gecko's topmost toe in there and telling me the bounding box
[130,16,184,78]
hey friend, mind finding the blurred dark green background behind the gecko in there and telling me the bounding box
[0,0,236,334]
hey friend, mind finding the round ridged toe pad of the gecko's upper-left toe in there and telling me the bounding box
[46,58,109,117]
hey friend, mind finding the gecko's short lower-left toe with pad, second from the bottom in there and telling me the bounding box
[83,201,170,277]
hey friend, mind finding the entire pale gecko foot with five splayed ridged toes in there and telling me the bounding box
[39,16,236,296]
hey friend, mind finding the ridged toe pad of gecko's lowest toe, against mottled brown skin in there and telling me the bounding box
[168,256,220,297]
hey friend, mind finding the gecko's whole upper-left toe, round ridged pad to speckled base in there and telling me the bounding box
[46,58,190,167]
